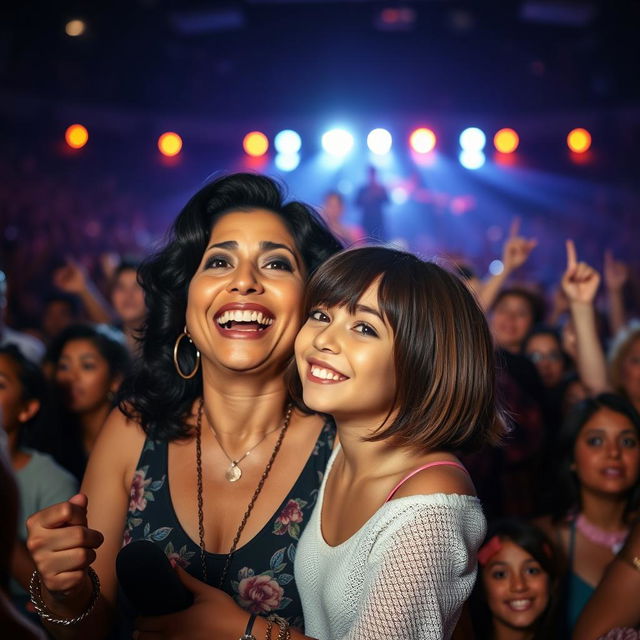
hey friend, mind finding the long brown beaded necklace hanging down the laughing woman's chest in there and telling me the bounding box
[196,398,293,589]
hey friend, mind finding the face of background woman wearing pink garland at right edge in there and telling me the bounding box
[574,407,640,495]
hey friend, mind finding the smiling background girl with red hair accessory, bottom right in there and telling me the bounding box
[471,518,559,640]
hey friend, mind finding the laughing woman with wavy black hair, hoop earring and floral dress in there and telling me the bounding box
[24,174,341,638]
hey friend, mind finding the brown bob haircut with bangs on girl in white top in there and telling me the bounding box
[290,247,505,452]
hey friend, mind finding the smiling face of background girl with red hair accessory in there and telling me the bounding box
[482,540,550,630]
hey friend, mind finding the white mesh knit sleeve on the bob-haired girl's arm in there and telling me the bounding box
[343,496,485,640]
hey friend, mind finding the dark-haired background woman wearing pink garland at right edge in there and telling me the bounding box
[539,393,640,629]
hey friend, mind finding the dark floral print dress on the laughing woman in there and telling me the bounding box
[123,421,335,629]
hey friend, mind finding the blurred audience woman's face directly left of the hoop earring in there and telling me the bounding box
[55,339,120,414]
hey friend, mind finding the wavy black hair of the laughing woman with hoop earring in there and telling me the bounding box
[120,173,342,440]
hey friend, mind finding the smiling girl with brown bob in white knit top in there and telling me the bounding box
[284,247,503,640]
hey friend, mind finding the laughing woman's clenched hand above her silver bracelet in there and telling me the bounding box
[27,493,103,599]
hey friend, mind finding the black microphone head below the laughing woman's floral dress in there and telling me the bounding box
[116,540,193,616]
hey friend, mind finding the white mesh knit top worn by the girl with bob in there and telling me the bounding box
[295,447,486,640]
